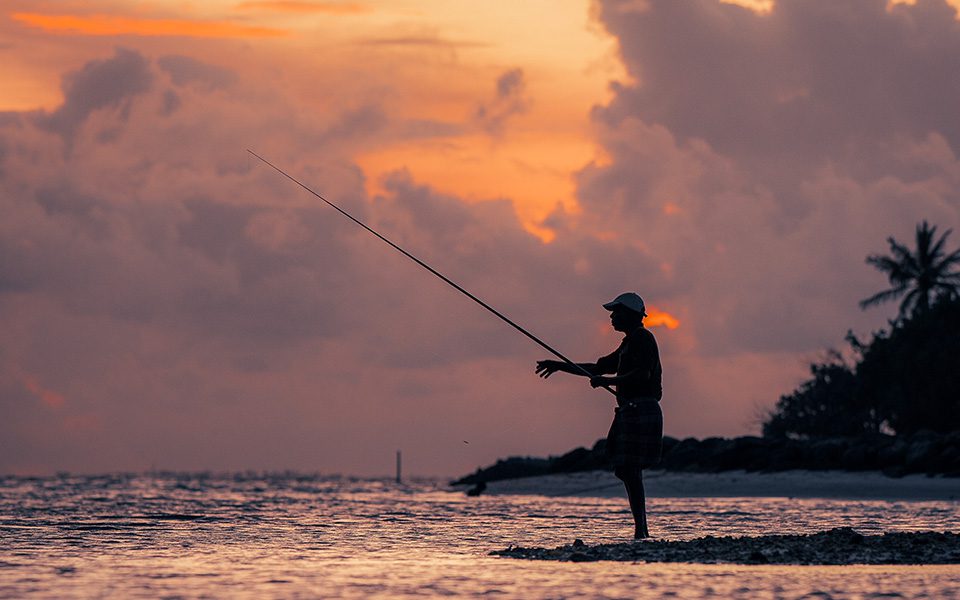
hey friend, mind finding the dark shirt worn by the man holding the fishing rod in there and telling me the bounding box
[597,325,663,403]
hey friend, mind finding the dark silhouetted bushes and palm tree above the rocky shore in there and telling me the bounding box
[763,221,960,438]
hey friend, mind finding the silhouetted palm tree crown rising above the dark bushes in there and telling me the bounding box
[860,221,960,319]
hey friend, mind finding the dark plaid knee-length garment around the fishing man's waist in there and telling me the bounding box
[607,398,663,469]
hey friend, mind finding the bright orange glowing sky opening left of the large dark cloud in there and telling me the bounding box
[0,0,623,240]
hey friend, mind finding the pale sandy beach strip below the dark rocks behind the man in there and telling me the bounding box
[474,470,960,501]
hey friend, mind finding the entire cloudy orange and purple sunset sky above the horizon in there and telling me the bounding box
[0,0,960,475]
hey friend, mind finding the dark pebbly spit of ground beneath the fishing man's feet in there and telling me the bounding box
[490,527,960,565]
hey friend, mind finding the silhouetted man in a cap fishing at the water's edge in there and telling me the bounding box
[536,292,663,539]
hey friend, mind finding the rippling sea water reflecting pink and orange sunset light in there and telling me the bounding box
[0,474,960,598]
